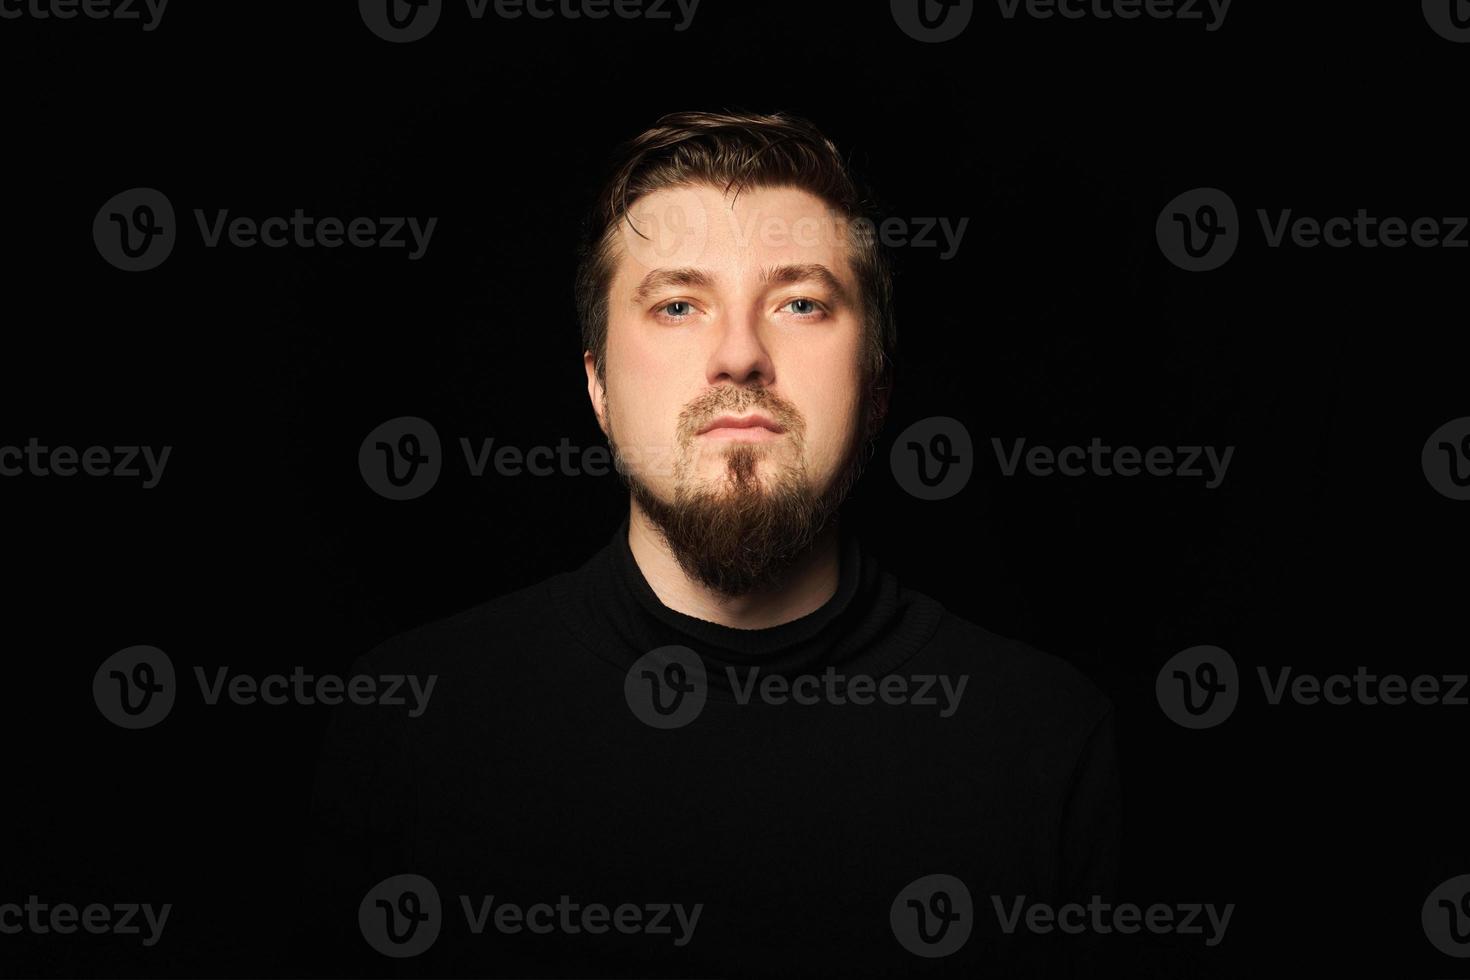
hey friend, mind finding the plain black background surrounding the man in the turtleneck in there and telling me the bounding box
[0,0,1470,976]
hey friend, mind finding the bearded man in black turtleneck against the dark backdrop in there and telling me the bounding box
[309,113,1119,977]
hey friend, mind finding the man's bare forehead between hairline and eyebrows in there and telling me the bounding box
[612,184,857,297]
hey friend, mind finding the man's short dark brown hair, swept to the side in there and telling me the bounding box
[576,112,897,399]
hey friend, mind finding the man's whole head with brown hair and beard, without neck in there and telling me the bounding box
[576,113,894,595]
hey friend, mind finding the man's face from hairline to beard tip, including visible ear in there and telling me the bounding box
[585,184,870,594]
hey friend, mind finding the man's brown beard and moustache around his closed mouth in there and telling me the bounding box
[604,386,876,597]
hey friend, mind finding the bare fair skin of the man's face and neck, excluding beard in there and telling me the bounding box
[584,184,863,629]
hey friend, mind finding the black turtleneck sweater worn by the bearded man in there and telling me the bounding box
[303,520,1119,977]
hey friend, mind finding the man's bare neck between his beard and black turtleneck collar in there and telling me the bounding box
[628,501,842,629]
